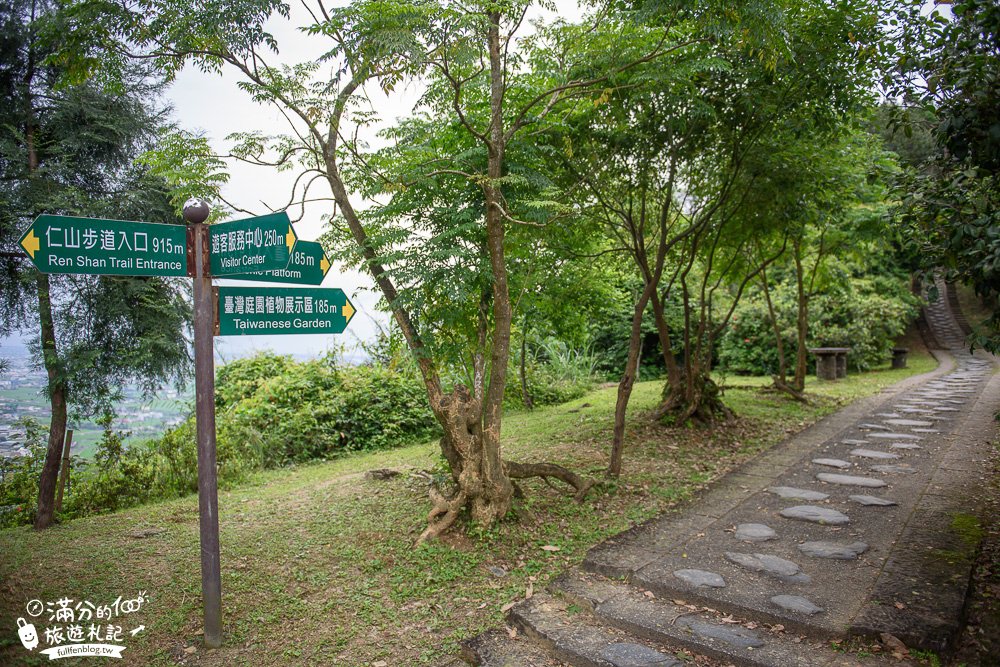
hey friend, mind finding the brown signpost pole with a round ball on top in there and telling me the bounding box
[184,201,222,648]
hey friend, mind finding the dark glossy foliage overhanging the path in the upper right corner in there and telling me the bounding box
[886,0,1000,351]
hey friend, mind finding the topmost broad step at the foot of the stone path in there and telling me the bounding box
[548,570,907,667]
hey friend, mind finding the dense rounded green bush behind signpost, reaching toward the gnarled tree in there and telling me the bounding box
[150,353,437,492]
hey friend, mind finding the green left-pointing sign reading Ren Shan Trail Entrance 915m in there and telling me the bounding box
[20,215,187,276]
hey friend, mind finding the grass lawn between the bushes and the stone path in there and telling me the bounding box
[0,353,936,667]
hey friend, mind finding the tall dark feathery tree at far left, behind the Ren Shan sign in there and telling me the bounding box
[0,0,189,528]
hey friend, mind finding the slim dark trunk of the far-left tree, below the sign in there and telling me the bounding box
[35,273,66,530]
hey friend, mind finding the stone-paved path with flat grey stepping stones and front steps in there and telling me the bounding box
[464,283,1000,667]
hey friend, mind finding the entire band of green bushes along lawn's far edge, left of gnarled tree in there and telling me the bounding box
[0,353,442,527]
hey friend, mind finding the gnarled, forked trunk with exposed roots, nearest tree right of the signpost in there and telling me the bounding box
[317,18,593,544]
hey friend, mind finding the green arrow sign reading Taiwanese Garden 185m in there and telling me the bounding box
[219,286,356,336]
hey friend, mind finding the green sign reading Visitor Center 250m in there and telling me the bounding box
[208,211,296,276]
